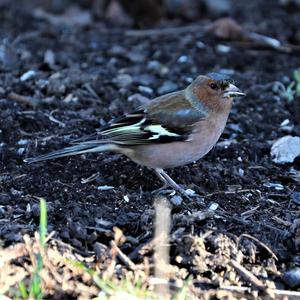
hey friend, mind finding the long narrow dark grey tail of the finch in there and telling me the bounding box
[24,143,116,164]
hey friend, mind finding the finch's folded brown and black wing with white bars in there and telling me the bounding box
[75,91,206,145]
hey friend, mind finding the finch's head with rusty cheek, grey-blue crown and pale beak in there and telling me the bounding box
[188,73,246,110]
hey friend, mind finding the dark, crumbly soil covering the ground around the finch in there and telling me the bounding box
[0,1,300,297]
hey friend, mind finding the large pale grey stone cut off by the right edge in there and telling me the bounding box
[271,135,300,164]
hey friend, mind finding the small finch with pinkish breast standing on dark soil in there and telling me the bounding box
[24,73,246,191]
